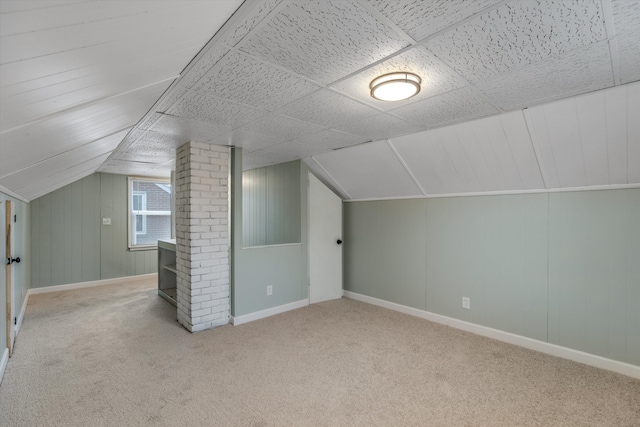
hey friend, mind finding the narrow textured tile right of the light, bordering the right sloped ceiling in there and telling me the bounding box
[476,40,613,110]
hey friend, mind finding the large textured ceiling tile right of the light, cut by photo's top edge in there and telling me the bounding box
[426,0,606,83]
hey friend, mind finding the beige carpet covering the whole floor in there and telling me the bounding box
[0,283,640,426]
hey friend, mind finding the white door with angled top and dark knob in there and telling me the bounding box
[309,173,342,304]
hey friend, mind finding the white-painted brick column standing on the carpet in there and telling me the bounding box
[175,142,230,332]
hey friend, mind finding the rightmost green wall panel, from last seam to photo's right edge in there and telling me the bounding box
[549,190,640,365]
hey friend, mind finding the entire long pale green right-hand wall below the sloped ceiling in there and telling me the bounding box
[344,189,640,365]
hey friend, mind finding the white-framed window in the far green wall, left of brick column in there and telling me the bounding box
[127,177,171,249]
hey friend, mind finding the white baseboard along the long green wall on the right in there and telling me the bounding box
[344,291,640,379]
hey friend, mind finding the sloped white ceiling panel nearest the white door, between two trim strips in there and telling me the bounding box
[314,141,423,199]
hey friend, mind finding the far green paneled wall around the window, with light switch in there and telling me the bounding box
[30,173,157,288]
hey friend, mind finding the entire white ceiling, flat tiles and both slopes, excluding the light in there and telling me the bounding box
[0,0,640,200]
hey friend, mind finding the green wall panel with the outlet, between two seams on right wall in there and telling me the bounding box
[426,194,548,341]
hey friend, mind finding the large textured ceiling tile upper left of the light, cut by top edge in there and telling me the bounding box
[239,0,407,84]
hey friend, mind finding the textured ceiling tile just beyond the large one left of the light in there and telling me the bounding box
[193,52,318,111]
